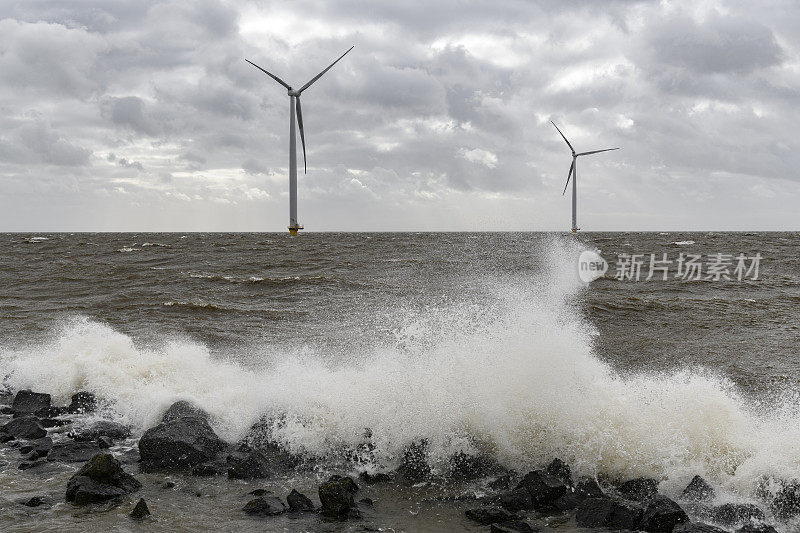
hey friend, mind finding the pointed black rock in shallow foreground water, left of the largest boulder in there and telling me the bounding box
[66,453,142,505]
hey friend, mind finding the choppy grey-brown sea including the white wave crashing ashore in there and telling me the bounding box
[0,233,800,531]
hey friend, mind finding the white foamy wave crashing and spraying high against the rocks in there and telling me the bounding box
[0,235,800,504]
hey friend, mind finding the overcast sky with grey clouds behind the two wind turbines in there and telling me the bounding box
[0,0,800,231]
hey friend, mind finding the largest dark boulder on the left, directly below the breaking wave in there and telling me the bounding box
[139,416,225,470]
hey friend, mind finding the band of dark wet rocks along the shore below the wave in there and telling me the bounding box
[0,390,800,533]
